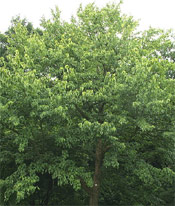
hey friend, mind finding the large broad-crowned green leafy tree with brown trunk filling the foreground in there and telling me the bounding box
[0,4,175,205]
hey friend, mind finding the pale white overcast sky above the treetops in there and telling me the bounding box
[0,0,175,32]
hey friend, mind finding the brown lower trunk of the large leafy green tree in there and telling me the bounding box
[89,139,103,206]
